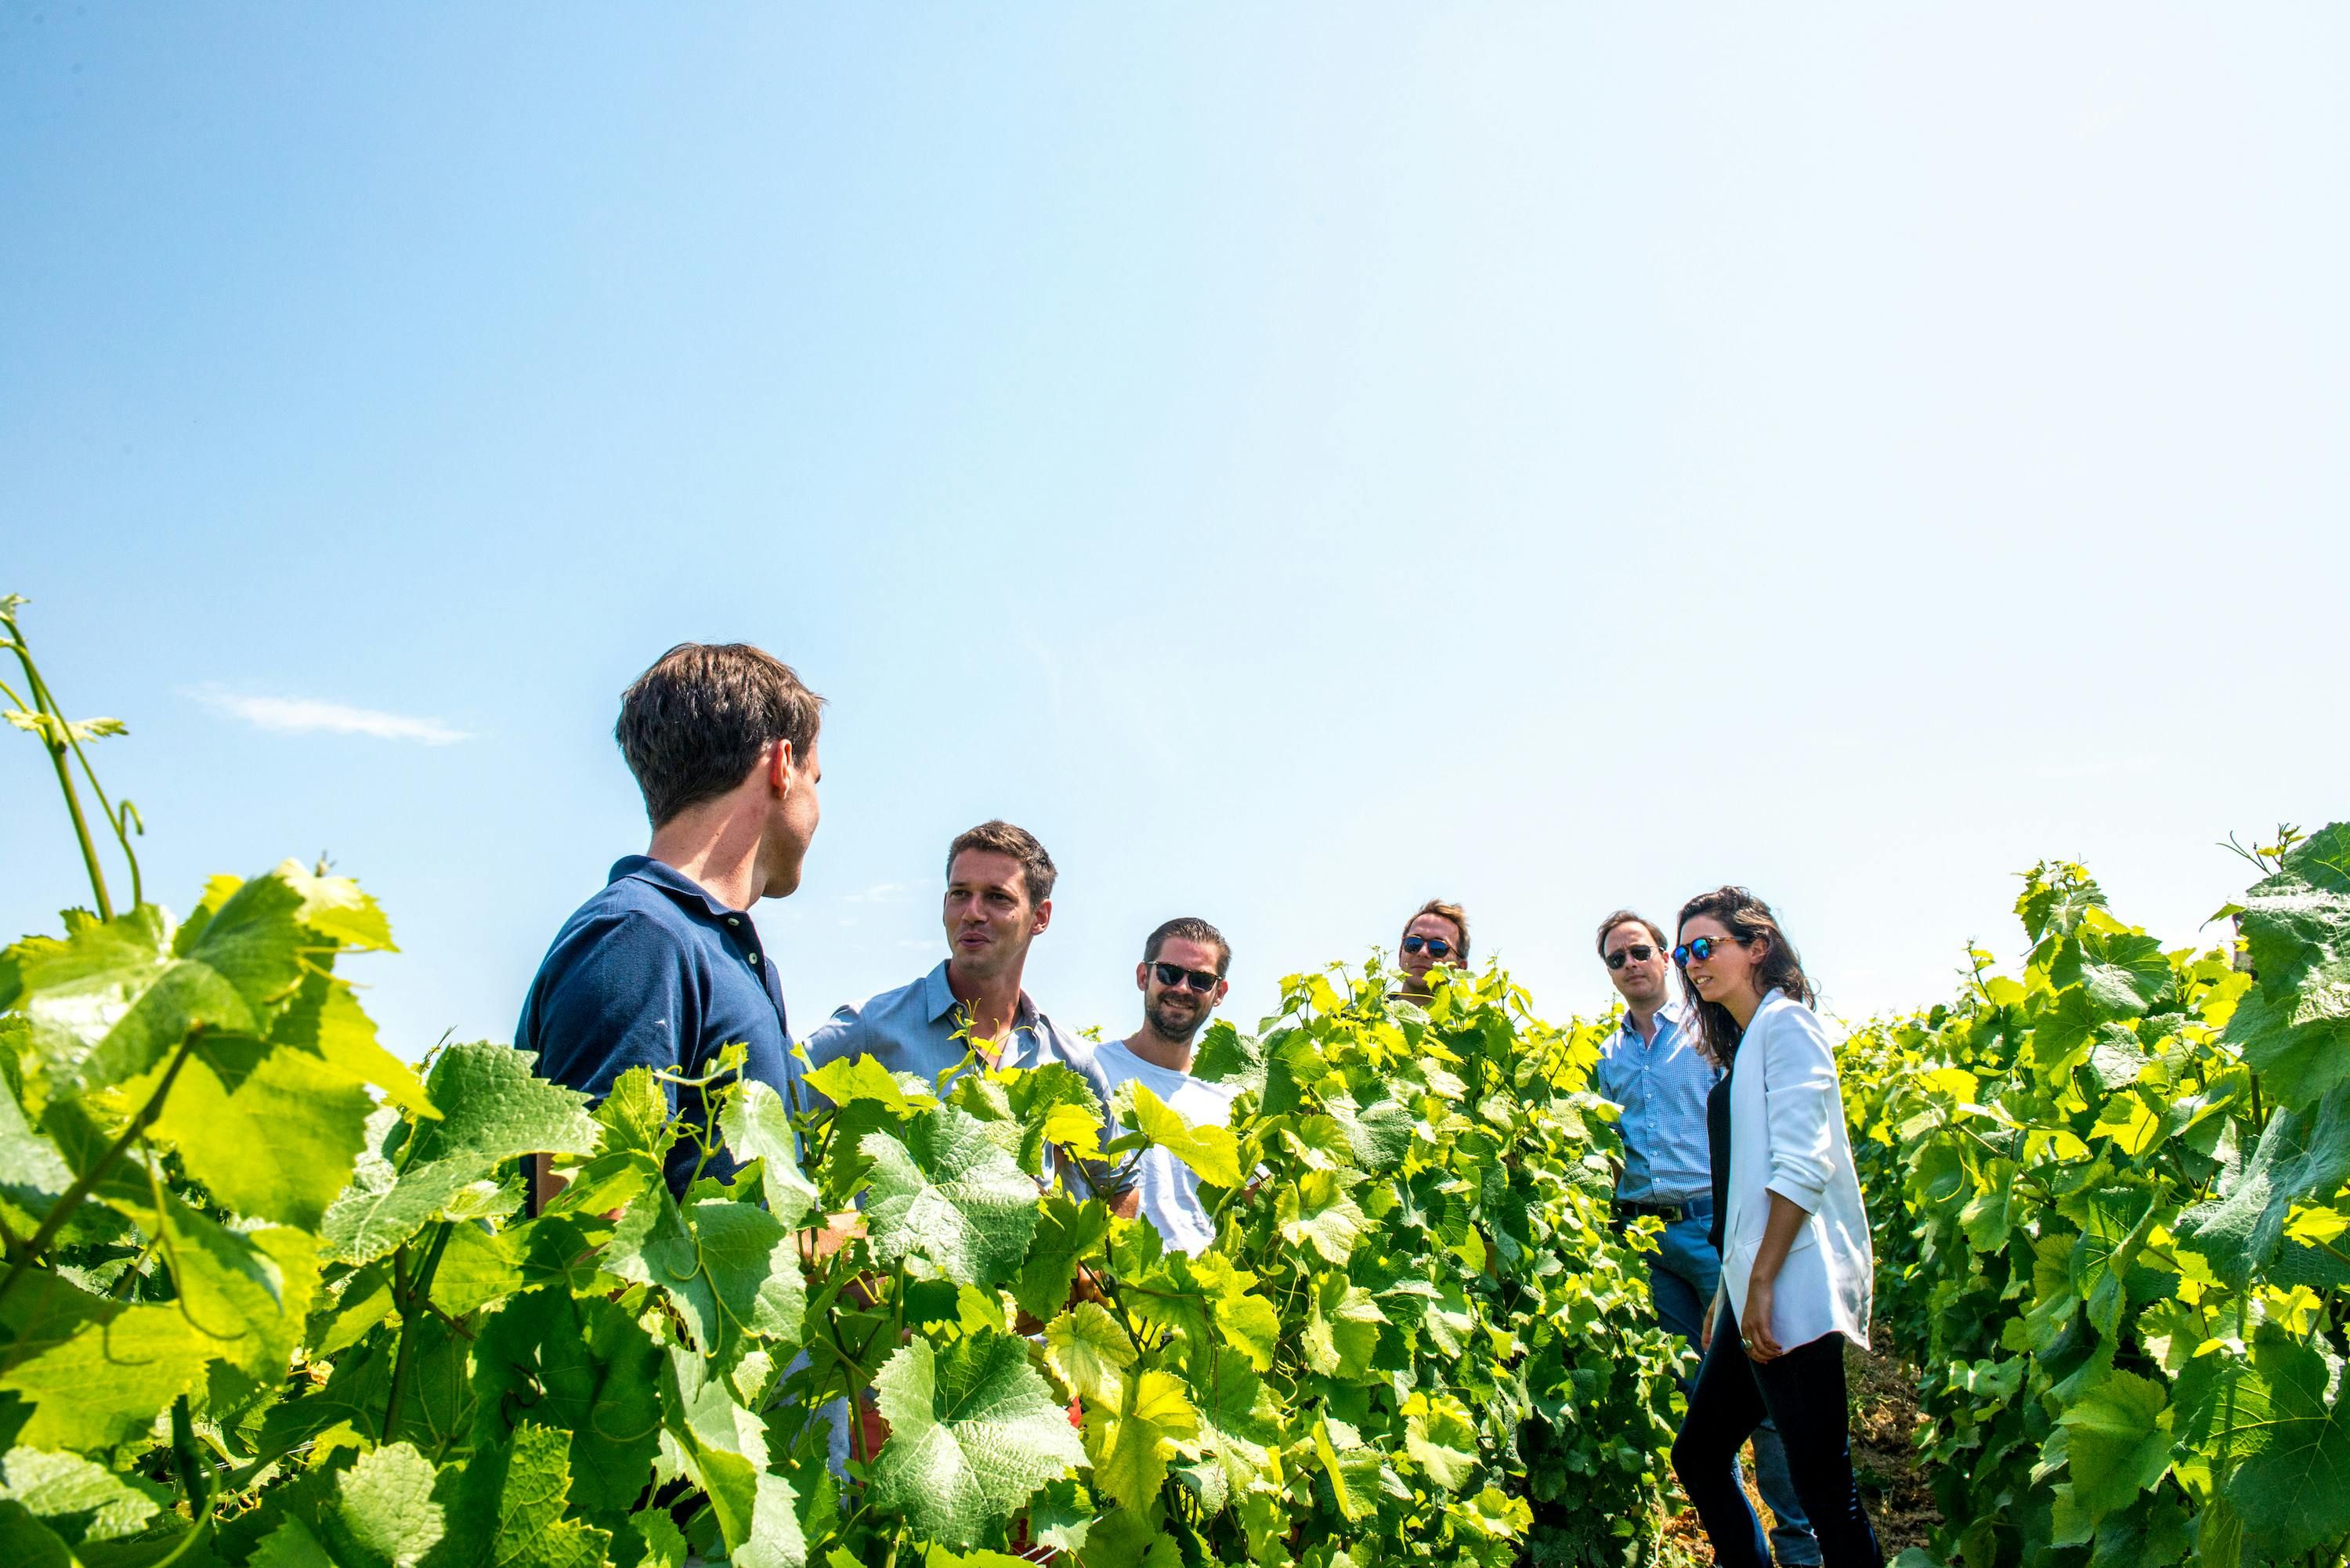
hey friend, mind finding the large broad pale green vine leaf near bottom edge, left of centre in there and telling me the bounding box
[867,1331,1086,1547]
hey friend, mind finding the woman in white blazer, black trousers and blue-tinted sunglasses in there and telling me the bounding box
[1673,887,1885,1568]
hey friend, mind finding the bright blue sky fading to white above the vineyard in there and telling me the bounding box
[0,0,2350,1053]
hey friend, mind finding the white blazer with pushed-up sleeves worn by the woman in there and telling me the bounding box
[1723,990,1875,1349]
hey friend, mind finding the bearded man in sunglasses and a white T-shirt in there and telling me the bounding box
[1095,917,1238,1255]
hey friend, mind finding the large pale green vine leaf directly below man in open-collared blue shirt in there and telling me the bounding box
[862,1105,1036,1286]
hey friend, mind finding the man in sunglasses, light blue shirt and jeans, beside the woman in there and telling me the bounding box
[1591,910,1819,1568]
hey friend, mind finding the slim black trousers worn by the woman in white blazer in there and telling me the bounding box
[1673,1302,1885,1568]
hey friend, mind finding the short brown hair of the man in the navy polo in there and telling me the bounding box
[611,641,825,828]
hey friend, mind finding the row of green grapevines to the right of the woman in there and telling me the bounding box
[1845,828,2350,1568]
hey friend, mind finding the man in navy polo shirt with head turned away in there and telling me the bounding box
[515,641,822,1192]
